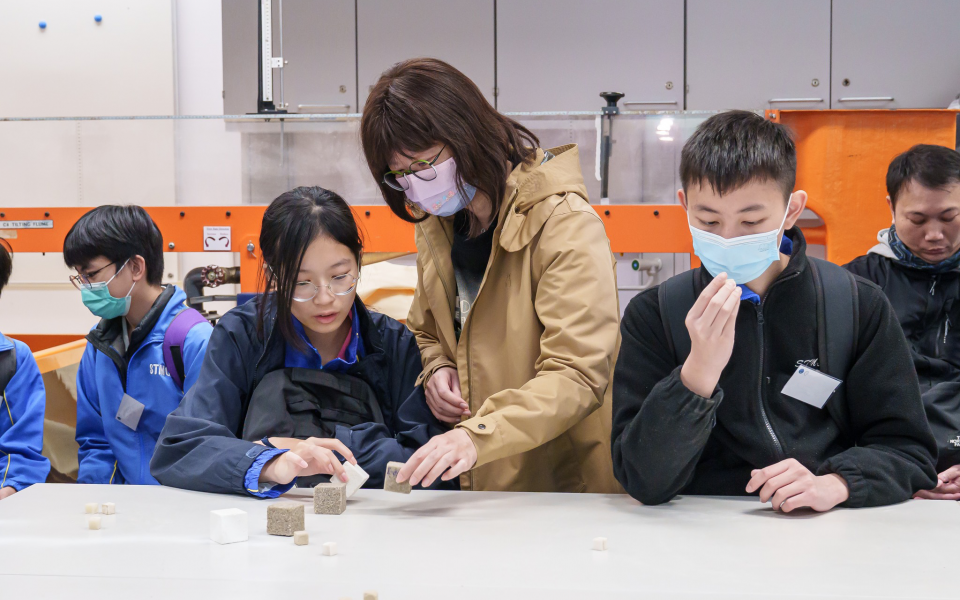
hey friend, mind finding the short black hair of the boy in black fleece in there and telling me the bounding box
[680,110,797,198]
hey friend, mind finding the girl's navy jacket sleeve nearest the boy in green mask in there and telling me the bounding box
[150,309,267,494]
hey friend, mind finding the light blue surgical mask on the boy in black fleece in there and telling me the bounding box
[687,203,790,284]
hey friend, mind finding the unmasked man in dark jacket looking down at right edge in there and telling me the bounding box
[846,145,960,500]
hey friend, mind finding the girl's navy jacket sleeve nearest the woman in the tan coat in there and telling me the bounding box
[336,329,456,489]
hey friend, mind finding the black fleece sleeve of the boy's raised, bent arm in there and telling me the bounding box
[612,288,723,504]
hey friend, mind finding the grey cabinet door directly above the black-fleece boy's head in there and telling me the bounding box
[687,0,830,110]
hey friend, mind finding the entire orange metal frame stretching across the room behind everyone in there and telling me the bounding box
[0,110,957,302]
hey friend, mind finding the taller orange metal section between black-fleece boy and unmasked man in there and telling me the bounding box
[767,110,957,264]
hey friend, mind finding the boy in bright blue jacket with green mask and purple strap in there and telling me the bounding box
[63,206,213,484]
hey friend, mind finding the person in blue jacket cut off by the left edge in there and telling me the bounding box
[0,240,50,500]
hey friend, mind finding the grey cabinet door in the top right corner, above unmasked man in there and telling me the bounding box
[831,0,960,108]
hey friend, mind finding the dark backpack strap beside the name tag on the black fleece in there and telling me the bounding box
[807,257,860,442]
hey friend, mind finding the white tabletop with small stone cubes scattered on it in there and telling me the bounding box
[0,484,960,600]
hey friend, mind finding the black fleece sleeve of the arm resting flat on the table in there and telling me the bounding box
[817,279,937,507]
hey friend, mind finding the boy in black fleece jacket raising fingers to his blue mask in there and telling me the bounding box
[613,111,936,512]
